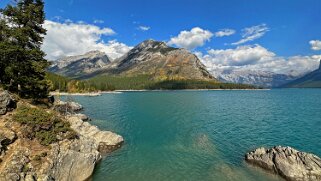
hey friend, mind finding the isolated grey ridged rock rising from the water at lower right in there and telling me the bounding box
[245,146,321,181]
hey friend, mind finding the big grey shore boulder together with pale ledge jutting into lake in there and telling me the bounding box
[43,115,124,181]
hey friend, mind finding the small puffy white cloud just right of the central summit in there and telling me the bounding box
[168,27,213,50]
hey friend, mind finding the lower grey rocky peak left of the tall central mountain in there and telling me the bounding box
[49,51,111,77]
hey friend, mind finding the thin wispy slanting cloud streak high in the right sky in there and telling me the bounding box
[232,24,269,45]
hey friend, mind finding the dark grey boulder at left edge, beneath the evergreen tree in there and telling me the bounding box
[0,91,17,115]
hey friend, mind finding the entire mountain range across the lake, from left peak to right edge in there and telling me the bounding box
[49,40,320,87]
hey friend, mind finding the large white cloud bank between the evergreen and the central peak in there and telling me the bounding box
[42,20,131,60]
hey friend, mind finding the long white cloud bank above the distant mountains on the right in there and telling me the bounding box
[196,45,321,76]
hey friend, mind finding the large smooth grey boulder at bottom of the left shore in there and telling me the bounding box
[48,137,101,181]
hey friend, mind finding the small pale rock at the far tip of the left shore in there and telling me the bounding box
[54,101,83,114]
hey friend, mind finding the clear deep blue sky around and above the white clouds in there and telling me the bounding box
[0,0,321,73]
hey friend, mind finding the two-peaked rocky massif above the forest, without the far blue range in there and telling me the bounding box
[49,40,216,81]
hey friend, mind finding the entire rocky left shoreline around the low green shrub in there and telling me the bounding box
[0,92,124,181]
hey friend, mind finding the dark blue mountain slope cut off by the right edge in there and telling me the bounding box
[282,60,321,88]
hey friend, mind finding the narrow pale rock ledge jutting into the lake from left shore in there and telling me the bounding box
[67,116,124,153]
